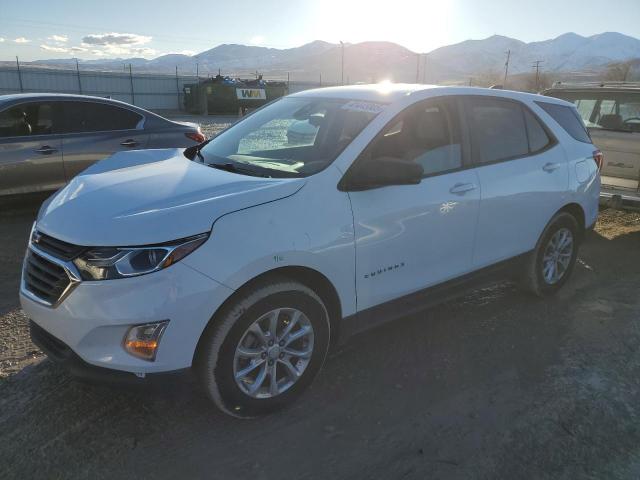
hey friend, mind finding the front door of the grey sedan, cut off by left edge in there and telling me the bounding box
[0,102,65,195]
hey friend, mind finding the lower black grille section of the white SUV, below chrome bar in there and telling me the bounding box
[23,249,71,305]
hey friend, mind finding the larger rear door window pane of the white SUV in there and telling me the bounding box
[467,97,529,163]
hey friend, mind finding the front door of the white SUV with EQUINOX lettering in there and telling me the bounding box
[349,99,480,311]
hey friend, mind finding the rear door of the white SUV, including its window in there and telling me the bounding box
[464,96,569,269]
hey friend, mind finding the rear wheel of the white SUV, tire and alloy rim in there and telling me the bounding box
[523,212,580,297]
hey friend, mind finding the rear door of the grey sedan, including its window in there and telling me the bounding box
[58,101,148,181]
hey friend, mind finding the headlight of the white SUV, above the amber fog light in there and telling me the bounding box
[73,233,209,280]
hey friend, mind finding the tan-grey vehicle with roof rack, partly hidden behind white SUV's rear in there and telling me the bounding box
[544,82,640,206]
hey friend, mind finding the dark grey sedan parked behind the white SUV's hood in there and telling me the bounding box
[0,94,205,196]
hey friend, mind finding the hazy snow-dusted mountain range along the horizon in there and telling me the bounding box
[22,32,640,83]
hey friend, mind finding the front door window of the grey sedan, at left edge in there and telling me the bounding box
[0,102,53,137]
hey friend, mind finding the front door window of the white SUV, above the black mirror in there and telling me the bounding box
[371,100,462,176]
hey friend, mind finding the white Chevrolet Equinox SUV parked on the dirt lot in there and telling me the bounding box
[21,85,600,416]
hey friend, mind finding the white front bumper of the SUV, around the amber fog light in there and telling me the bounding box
[20,263,233,378]
